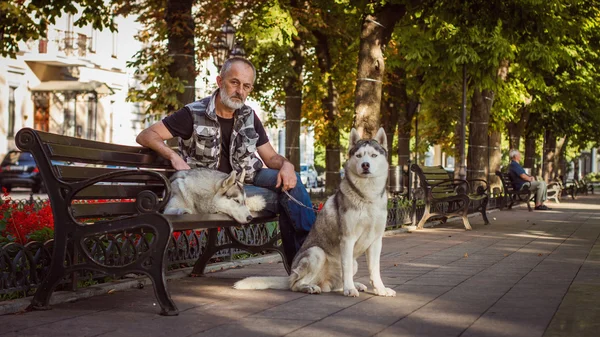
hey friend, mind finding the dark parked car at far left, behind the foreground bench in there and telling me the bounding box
[0,151,44,193]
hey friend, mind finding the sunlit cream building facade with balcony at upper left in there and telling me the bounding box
[0,15,143,159]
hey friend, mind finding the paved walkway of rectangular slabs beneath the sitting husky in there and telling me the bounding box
[0,196,600,337]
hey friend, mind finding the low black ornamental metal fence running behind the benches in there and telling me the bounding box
[0,196,503,300]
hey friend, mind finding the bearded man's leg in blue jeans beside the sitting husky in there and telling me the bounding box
[254,168,316,265]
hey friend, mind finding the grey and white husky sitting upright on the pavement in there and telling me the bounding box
[234,128,396,297]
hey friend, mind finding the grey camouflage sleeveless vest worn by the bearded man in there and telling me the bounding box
[179,91,263,183]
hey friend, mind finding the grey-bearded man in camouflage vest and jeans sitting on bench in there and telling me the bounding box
[136,57,315,265]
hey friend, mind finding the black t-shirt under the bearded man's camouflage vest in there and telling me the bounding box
[162,107,269,173]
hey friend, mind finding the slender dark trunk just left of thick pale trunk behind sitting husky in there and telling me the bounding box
[313,31,341,195]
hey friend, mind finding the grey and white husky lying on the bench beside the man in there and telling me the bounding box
[163,168,266,224]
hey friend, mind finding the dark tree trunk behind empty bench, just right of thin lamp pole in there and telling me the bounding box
[467,88,494,179]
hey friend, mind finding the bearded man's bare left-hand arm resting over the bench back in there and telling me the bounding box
[135,121,190,170]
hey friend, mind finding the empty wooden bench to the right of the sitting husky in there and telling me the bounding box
[411,164,490,229]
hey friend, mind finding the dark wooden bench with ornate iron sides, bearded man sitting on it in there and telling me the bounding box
[15,128,289,315]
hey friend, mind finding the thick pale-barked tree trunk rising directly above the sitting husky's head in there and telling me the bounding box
[354,3,406,138]
